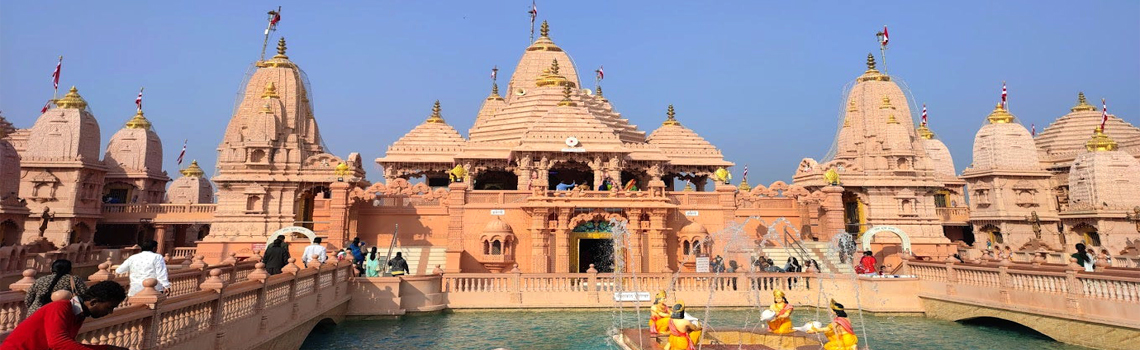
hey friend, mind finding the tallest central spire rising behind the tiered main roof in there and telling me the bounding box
[506,21,581,101]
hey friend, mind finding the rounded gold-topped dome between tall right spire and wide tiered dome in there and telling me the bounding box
[966,105,1041,172]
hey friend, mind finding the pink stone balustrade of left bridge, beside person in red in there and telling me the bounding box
[0,259,353,350]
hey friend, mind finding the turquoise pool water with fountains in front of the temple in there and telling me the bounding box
[301,309,1088,350]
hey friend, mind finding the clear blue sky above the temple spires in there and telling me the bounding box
[0,0,1140,185]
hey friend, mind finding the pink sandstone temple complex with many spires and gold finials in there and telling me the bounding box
[0,23,1140,274]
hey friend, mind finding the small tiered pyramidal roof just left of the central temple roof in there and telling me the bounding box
[376,100,466,163]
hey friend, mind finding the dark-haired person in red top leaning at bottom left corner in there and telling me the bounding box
[0,280,127,350]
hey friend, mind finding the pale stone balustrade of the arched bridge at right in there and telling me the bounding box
[905,261,1140,328]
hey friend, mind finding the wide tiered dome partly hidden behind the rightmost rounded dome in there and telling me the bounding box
[1035,92,1140,166]
